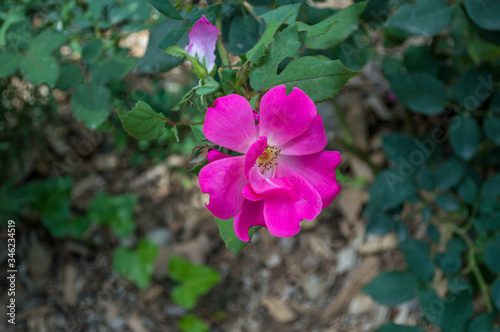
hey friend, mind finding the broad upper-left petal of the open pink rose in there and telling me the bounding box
[203,95,257,152]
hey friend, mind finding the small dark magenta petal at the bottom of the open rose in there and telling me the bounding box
[234,200,266,242]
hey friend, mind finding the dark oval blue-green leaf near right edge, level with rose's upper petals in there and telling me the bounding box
[449,114,481,160]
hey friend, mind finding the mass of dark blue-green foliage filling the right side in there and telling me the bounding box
[358,0,500,332]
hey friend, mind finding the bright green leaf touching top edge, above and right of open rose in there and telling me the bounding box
[306,1,367,50]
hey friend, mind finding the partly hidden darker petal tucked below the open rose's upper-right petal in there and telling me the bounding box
[280,114,327,155]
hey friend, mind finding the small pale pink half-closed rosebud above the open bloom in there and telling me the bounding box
[186,15,220,73]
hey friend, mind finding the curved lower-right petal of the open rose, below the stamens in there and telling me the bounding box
[264,163,322,237]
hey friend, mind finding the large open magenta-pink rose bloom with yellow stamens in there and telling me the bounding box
[199,86,341,242]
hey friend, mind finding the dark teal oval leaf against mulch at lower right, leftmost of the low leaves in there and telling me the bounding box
[363,271,417,307]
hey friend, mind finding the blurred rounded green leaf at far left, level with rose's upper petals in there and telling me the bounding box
[71,83,111,129]
